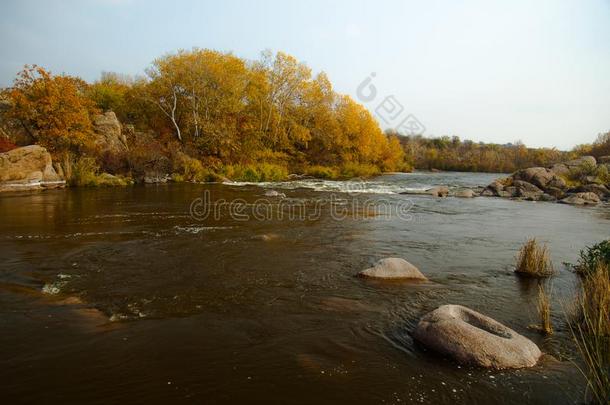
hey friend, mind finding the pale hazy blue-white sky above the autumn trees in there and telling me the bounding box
[0,0,610,149]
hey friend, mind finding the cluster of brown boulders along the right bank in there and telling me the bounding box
[481,156,610,205]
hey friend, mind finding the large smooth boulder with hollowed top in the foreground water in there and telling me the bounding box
[414,305,542,369]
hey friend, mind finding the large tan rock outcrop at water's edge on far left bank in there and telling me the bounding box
[0,145,66,191]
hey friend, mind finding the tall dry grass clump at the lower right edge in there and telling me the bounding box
[569,263,610,404]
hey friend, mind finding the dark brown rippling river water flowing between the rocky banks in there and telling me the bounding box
[0,173,610,404]
